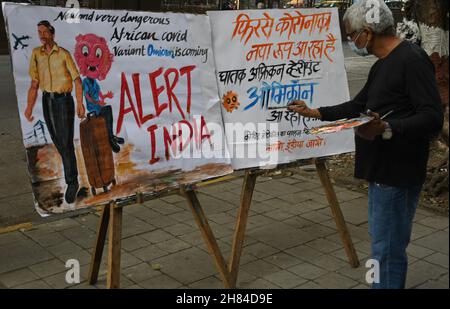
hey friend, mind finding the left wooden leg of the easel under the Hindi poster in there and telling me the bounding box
[228,171,257,286]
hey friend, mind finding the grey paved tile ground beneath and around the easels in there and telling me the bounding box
[0,169,449,289]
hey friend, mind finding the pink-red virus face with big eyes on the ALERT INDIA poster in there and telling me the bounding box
[75,33,113,80]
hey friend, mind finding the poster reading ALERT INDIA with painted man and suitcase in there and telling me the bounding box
[3,4,232,215]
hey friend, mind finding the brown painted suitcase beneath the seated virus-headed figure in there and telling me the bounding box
[80,113,116,195]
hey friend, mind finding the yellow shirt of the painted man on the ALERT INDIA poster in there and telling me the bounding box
[29,43,80,93]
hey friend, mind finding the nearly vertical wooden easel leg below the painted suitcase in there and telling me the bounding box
[106,203,122,289]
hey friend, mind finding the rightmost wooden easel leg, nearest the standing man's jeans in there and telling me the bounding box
[315,159,359,268]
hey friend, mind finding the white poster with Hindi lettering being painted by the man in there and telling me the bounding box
[208,8,354,169]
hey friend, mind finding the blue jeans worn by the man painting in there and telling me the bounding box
[369,183,422,289]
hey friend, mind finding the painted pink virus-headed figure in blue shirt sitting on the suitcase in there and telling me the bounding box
[75,33,125,153]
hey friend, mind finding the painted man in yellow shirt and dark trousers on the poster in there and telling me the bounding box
[24,20,85,204]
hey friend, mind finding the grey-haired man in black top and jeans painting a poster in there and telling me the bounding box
[289,0,444,289]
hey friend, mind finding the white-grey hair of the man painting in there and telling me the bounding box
[343,0,395,34]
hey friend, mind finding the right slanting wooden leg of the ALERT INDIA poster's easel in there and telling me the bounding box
[181,189,235,289]
